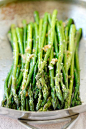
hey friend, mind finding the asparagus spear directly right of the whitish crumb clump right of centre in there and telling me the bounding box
[55,23,63,102]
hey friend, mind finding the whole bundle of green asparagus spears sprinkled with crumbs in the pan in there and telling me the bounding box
[2,10,82,111]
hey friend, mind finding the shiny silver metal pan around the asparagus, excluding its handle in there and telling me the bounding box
[0,1,86,120]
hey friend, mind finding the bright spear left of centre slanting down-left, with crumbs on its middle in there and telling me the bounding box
[21,24,32,110]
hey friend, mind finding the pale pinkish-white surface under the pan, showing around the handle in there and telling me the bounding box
[0,112,86,129]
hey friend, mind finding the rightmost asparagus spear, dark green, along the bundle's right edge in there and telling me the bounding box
[72,28,82,106]
